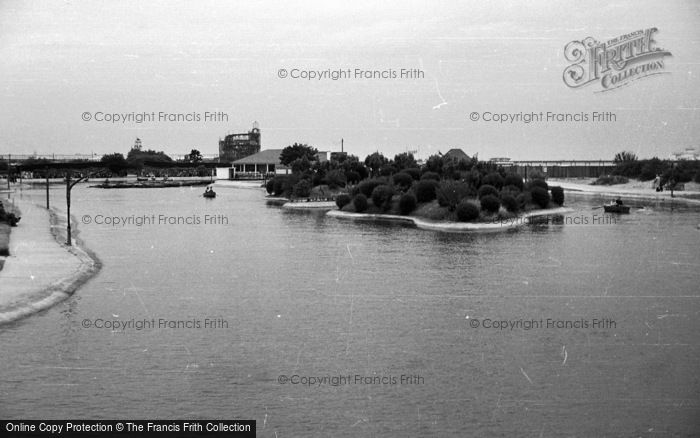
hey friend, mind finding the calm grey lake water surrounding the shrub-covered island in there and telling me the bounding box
[0,186,700,438]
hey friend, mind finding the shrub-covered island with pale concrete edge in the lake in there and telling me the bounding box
[265,145,566,230]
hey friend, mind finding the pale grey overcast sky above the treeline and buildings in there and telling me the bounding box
[0,0,700,159]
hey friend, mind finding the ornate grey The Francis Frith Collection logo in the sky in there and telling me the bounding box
[564,27,671,91]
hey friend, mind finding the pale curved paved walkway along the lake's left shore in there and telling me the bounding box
[0,200,98,323]
